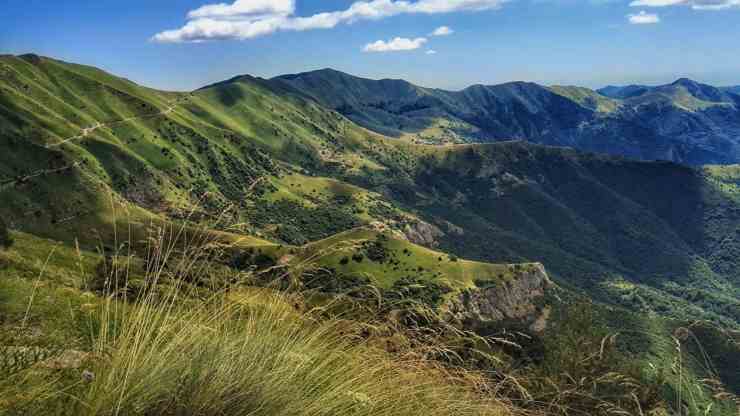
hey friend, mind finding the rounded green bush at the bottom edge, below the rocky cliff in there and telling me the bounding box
[508,302,666,415]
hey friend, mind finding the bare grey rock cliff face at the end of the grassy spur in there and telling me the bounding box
[444,263,552,332]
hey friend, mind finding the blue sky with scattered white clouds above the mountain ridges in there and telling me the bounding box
[0,0,740,90]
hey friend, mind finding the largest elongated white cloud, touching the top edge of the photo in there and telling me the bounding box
[152,0,506,42]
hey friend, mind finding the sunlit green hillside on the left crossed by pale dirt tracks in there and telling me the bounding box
[0,56,416,245]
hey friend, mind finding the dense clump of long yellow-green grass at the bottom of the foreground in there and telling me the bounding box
[76,292,502,415]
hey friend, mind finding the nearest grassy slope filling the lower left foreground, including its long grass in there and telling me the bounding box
[0,233,511,416]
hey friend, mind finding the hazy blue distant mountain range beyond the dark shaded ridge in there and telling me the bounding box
[274,70,740,165]
